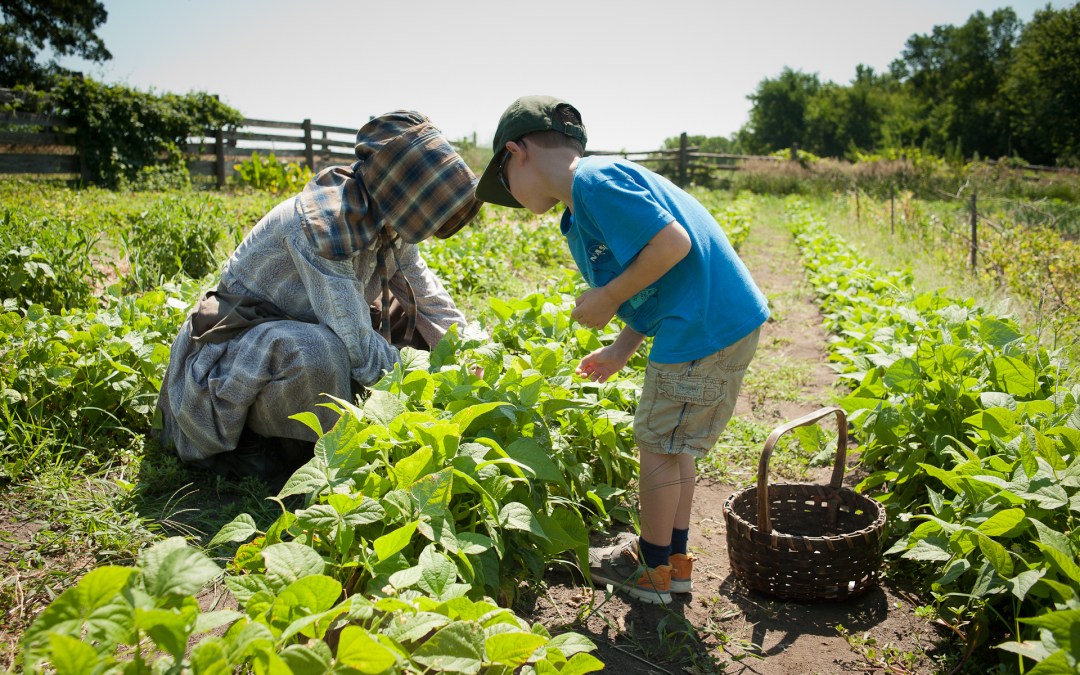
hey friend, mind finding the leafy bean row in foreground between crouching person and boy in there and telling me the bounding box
[23,287,637,673]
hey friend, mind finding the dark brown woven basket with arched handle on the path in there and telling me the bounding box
[724,407,885,600]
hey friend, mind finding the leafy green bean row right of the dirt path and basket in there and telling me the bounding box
[788,201,1080,673]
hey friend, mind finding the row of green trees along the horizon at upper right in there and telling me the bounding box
[708,3,1080,166]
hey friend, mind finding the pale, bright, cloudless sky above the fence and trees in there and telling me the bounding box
[56,0,1074,150]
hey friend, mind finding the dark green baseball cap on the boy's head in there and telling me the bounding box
[476,96,588,208]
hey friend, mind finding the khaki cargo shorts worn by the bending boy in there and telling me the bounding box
[634,326,761,457]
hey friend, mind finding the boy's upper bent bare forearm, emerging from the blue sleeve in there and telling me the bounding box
[570,220,691,328]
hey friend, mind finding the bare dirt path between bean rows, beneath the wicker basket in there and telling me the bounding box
[518,203,941,674]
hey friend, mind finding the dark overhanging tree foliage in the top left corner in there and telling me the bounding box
[0,0,112,86]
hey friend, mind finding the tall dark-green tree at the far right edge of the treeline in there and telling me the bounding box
[1004,3,1080,166]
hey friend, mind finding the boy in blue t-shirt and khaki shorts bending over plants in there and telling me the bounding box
[476,96,769,603]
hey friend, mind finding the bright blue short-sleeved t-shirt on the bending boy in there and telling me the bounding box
[562,157,769,363]
